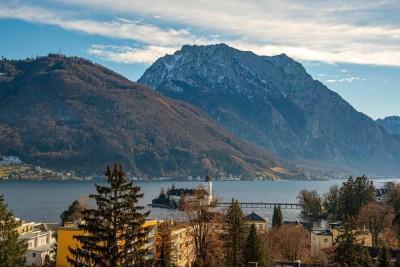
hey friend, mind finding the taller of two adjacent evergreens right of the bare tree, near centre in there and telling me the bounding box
[224,199,248,267]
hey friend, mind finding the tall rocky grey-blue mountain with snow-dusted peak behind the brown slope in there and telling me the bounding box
[138,44,400,174]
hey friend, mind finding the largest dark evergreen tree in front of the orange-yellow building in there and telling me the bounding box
[67,163,149,267]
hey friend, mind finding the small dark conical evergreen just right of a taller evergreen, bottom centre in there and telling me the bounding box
[244,223,266,267]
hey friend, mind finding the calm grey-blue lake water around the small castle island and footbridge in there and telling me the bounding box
[0,179,394,225]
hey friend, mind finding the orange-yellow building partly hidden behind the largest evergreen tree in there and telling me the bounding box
[56,220,157,267]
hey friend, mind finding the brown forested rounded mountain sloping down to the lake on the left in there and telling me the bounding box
[0,54,293,177]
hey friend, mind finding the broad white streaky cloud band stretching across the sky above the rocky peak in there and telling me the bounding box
[0,0,400,66]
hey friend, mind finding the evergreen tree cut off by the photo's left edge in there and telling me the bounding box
[0,195,27,267]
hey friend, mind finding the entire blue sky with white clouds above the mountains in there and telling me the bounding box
[0,0,400,119]
